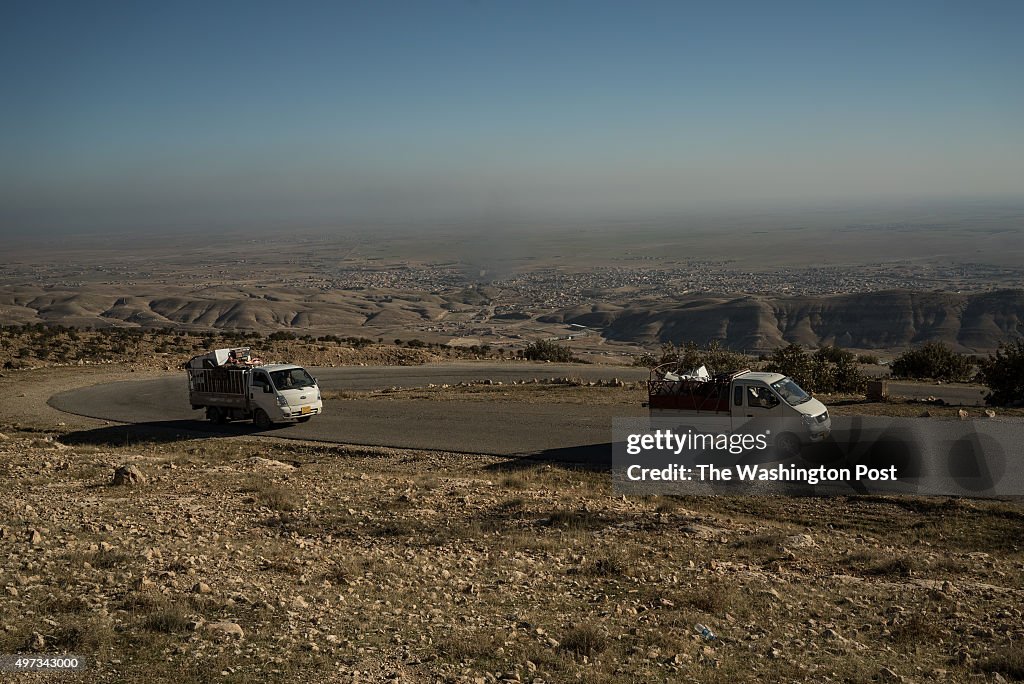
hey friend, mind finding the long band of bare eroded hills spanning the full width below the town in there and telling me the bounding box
[0,286,1024,352]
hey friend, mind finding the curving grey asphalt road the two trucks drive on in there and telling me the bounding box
[50,362,991,455]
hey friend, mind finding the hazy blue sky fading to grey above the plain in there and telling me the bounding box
[0,0,1024,236]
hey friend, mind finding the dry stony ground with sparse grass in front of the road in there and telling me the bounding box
[0,368,1024,683]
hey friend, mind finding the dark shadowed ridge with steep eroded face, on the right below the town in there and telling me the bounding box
[541,290,1024,351]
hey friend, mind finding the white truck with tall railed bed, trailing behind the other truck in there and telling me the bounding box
[185,347,324,429]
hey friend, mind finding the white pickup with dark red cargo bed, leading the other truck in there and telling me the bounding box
[647,364,831,454]
